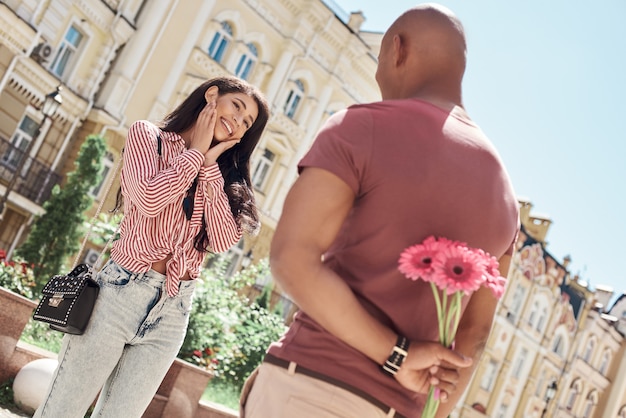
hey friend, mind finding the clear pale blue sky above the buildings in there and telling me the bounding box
[335,0,626,300]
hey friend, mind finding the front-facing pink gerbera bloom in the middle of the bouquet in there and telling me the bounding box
[432,242,484,295]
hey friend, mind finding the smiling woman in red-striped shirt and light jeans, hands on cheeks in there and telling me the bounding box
[35,77,269,418]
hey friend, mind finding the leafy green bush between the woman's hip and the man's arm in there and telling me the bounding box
[179,256,286,390]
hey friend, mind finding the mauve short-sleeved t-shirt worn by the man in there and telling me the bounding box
[269,99,519,417]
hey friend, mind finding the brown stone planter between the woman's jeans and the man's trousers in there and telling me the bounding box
[142,358,213,418]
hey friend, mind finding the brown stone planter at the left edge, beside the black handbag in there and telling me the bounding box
[0,287,37,383]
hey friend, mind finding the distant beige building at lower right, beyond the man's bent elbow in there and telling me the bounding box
[453,201,626,418]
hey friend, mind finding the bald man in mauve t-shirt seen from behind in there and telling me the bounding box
[242,4,519,418]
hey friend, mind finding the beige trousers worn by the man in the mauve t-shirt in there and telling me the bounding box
[239,363,395,418]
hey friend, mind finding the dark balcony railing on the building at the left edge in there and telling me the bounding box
[0,137,62,206]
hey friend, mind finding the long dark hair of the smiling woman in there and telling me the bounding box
[114,77,269,252]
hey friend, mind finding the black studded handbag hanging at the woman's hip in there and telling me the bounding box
[33,264,100,335]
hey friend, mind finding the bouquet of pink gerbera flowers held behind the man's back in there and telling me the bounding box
[398,236,506,418]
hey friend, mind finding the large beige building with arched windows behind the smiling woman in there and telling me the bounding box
[0,0,381,270]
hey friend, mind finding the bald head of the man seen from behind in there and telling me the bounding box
[376,3,466,104]
